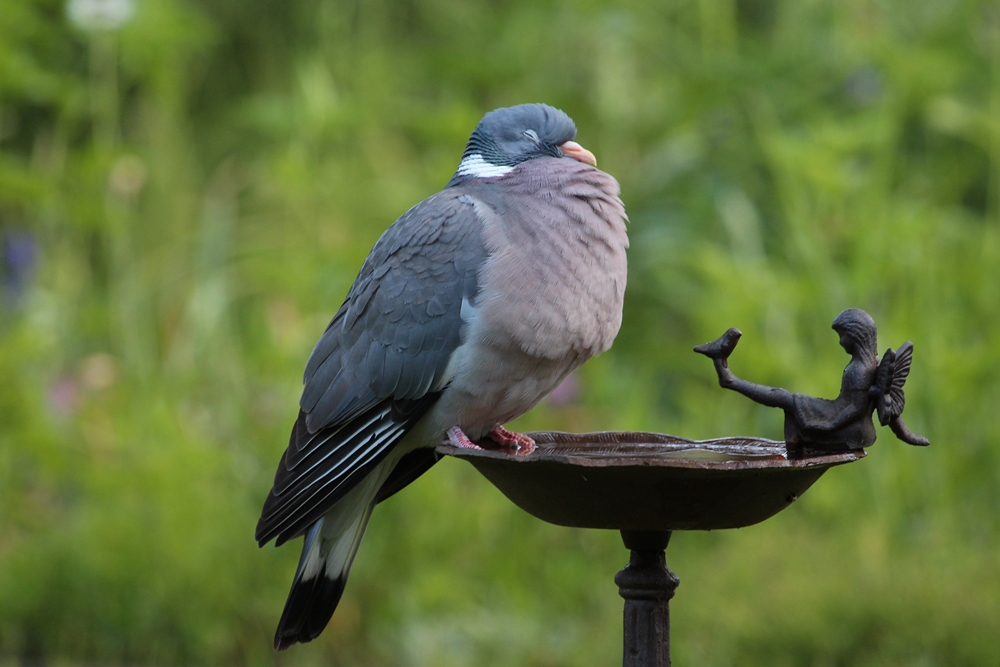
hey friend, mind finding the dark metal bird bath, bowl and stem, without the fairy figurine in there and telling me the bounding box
[438,432,865,667]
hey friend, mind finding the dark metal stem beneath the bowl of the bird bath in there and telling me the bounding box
[615,530,680,667]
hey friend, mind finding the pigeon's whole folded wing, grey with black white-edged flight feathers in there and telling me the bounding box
[257,192,486,544]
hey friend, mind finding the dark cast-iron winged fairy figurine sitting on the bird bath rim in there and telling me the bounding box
[694,308,930,453]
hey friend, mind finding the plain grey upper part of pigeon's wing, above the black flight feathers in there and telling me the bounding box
[300,193,486,432]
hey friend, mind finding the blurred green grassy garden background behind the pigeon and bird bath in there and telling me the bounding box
[0,0,1000,667]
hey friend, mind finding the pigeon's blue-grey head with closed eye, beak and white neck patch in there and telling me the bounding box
[449,104,597,185]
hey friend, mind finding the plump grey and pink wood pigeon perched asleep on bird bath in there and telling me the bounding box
[256,104,628,650]
